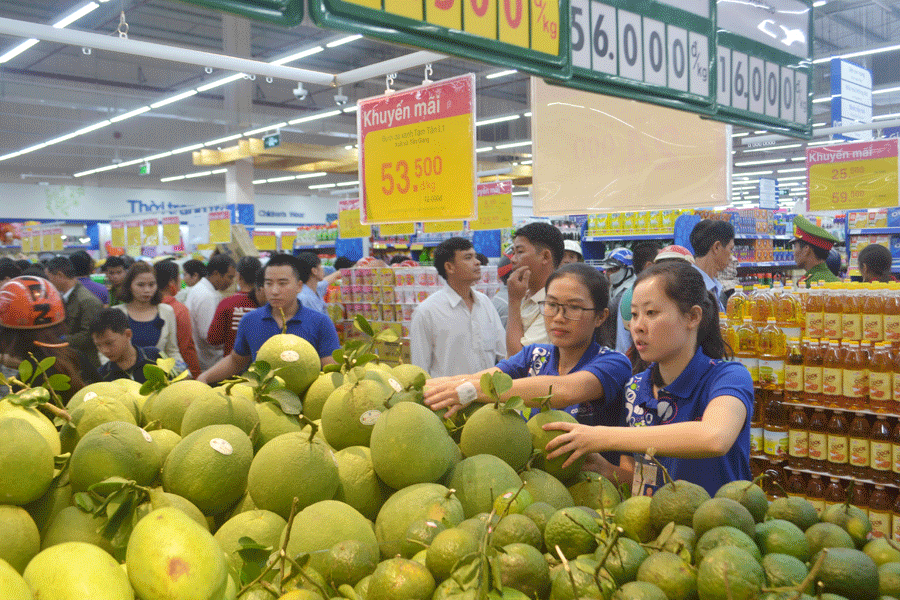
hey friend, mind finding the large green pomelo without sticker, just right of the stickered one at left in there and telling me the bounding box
[247,432,340,519]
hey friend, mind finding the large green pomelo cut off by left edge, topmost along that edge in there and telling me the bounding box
[0,419,53,506]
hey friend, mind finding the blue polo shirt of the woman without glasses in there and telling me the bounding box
[625,348,753,496]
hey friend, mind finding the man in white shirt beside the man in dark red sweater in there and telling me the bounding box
[184,254,237,371]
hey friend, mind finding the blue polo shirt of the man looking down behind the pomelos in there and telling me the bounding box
[234,302,340,362]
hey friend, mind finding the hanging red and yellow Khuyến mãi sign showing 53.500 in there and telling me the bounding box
[356,74,477,224]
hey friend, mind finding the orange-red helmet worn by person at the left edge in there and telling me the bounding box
[0,275,66,329]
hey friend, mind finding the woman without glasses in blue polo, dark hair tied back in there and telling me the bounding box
[545,261,753,495]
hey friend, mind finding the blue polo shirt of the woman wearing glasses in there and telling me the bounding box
[497,342,631,464]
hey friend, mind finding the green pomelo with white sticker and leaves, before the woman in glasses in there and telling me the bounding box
[459,404,532,471]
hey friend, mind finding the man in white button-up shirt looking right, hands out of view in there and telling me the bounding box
[409,237,506,377]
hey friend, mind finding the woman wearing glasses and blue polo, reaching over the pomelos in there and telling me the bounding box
[425,263,631,475]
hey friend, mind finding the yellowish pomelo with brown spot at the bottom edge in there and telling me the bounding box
[125,508,228,600]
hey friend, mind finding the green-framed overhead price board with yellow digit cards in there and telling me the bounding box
[309,0,572,79]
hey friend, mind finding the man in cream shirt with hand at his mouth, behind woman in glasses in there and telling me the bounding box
[506,223,564,356]
